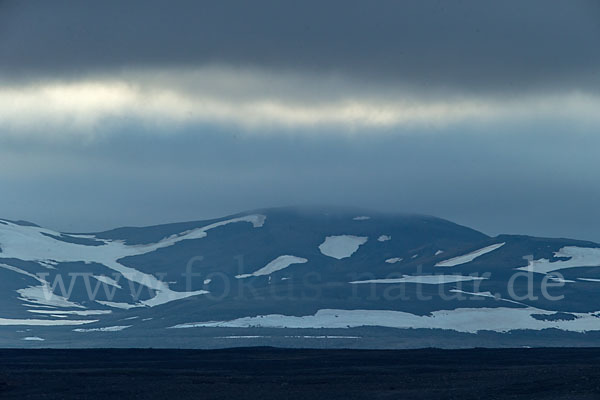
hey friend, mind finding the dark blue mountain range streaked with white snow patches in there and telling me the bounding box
[0,208,600,348]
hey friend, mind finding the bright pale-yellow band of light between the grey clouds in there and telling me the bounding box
[0,68,600,136]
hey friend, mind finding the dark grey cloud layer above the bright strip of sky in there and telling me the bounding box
[0,0,600,92]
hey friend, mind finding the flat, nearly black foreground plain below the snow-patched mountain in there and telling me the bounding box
[0,348,600,400]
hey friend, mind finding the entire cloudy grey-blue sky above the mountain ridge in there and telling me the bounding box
[0,0,600,242]
